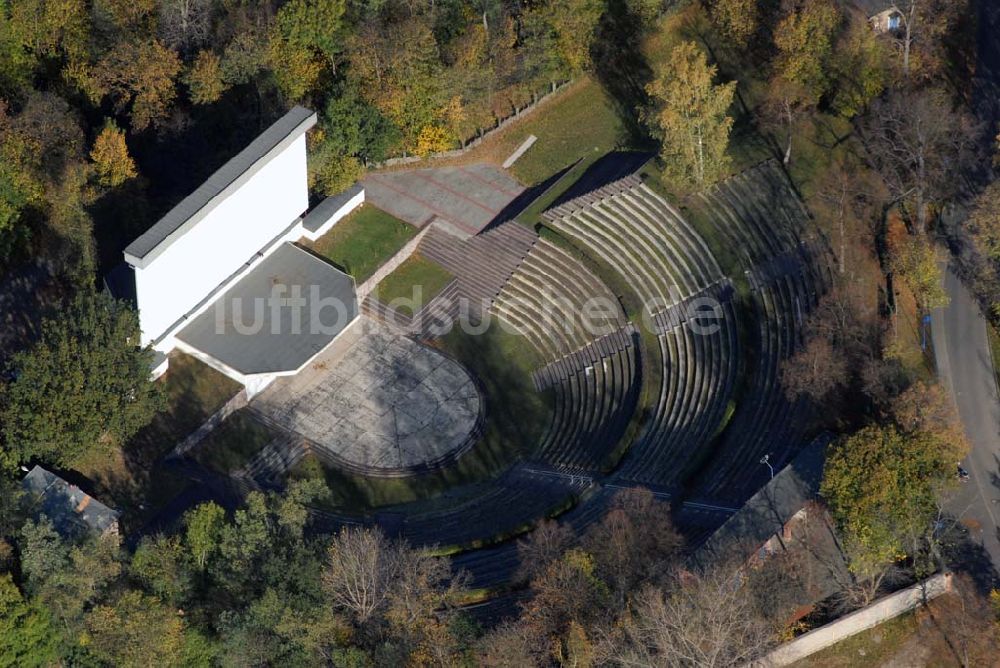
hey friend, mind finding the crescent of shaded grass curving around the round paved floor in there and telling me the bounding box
[292,323,552,512]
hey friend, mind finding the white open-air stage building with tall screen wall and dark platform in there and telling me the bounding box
[112,107,364,395]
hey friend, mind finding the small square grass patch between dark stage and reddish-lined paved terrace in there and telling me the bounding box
[310,204,417,283]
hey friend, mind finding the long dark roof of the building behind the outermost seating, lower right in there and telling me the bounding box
[694,435,830,565]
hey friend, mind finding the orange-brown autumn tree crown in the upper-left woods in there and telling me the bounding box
[94,39,181,132]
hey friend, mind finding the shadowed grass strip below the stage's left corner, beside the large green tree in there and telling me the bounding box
[76,354,240,528]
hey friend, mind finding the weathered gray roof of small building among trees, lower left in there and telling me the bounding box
[21,466,120,537]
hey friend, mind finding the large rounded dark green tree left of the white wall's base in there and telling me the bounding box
[0,292,162,466]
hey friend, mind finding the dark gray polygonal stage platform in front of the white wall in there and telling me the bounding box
[177,242,358,375]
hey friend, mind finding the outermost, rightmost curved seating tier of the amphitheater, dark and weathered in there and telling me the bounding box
[693,161,830,505]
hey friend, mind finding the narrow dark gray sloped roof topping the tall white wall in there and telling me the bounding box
[125,106,316,266]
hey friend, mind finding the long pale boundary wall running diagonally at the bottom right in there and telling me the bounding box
[755,573,951,668]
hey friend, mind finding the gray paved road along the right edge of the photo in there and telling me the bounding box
[933,270,1000,571]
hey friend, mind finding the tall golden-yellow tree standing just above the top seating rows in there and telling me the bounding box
[647,42,736,187]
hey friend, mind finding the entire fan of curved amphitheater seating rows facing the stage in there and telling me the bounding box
[234,155,831,604]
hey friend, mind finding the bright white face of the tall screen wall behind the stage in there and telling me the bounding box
[135,135,309,345]
